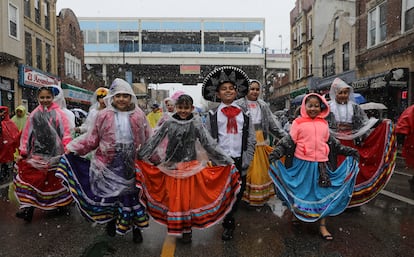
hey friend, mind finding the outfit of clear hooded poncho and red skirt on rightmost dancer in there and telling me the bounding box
[328,79,397,207]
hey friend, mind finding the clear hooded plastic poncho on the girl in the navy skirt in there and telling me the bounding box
[68,79,151,198]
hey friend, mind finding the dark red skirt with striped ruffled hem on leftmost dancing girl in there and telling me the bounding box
[14,160,73,210]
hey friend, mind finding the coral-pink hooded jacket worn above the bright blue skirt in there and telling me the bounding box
[290,93,329,162]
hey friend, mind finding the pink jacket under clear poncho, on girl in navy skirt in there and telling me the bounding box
[68,107,152,163]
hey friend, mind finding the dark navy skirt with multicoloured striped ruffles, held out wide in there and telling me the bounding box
[56,154,149,235]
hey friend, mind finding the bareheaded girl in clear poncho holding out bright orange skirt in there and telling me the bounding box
[137,94,240,243]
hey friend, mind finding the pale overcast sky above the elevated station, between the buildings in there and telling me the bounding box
[56,0,295,51]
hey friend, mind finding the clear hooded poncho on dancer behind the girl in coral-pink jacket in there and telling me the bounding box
[327,78,378,140]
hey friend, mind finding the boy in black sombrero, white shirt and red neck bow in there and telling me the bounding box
[202,66,256,241]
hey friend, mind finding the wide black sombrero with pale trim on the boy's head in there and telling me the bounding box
[201,66,249,102]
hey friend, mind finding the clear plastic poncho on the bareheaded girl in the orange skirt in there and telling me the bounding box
[138,114,233,178]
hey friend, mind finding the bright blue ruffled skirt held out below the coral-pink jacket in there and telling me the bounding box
[269,157,359,222]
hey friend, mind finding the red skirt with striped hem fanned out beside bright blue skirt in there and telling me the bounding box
[339,119,397,207]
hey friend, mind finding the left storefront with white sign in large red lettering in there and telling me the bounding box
[19,64,60,112]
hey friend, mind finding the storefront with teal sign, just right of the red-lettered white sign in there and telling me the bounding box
[62,83,93,111]
